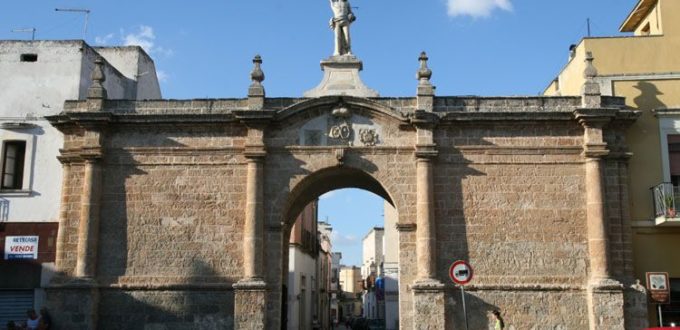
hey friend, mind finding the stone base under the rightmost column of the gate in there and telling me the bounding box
[588,280,625,330]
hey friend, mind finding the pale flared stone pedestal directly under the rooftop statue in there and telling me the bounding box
[304,55,379,97]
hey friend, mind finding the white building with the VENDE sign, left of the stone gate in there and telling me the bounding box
[0,40,161,326]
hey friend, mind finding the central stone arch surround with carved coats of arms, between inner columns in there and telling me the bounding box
[252,97,416,329]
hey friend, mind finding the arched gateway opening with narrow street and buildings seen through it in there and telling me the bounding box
[281,166,399,330]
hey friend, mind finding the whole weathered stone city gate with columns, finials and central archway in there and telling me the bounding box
[48,55,644,329]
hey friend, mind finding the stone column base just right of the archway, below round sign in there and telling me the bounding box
[411,281,446,330]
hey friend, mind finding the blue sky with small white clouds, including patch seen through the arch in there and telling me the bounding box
[0,0,637,264]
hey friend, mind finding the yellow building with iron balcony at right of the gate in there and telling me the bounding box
[544,0,680,325]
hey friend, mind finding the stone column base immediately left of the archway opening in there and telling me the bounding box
[234,280,267,330]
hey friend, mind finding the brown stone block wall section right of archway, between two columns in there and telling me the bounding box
[435,123,588,285]
